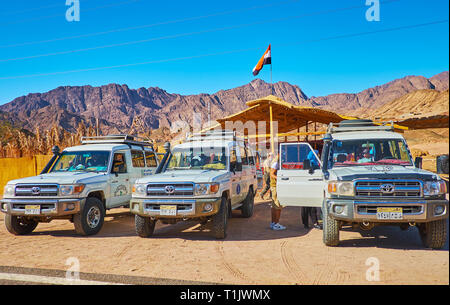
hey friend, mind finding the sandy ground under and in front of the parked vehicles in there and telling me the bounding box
[0,196,449,285]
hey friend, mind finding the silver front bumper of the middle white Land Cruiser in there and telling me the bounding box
[130,197,222,218]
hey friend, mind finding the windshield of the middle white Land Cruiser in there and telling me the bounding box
[167,147,228,170]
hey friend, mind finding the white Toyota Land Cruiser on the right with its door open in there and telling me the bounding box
[277,120,448,249]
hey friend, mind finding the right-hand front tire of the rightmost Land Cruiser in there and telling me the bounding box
[419,219,447,249]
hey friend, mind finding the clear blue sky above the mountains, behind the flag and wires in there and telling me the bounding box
[0,0,449,104]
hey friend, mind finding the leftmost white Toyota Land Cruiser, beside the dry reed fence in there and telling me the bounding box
[0,135,159,235]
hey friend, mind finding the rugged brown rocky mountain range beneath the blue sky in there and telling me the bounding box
[0,71,449,132]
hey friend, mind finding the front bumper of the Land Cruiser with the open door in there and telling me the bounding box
[326,199,449,223]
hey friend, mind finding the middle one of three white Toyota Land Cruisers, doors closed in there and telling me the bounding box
[130,131,257,239]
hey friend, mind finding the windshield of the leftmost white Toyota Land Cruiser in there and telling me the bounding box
[50,151,110,173]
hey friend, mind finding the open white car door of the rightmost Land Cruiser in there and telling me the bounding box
[277,143,325,207]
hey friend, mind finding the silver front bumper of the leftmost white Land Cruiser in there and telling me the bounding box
[0,198,85,217]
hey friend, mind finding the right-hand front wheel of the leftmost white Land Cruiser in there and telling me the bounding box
[73,197,105,236]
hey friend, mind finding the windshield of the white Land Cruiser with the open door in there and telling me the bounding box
[330,139,412,166]
